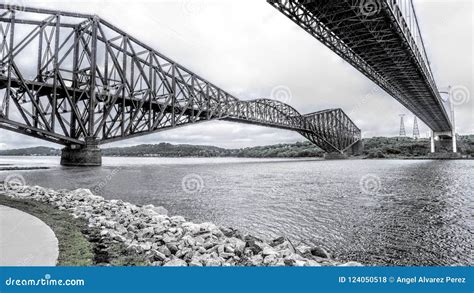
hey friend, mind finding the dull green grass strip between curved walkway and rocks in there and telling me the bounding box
[0,194,145,266]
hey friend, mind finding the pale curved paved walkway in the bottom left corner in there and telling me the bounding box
[0,205,58,266]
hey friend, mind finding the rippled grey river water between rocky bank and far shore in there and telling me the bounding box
[0,157,474,265]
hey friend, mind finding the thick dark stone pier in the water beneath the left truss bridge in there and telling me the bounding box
[61,137,102,167]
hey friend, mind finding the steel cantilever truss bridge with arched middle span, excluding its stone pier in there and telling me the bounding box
[0,5,361,152]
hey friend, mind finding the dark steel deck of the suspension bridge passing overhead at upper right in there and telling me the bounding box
[267,0,452,132]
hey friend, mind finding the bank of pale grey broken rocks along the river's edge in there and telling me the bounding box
[0,185,361,266]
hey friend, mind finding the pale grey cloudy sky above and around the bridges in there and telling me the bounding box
[0,0,474,149]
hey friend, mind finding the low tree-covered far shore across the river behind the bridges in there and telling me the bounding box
[0,135,474,158]
